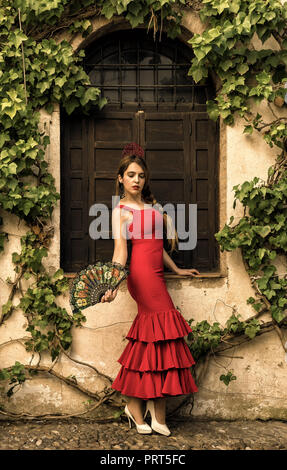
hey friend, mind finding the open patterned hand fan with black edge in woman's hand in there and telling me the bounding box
[70,261,129,312]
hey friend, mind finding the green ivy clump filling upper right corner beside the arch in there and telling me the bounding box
[189,0,287,138]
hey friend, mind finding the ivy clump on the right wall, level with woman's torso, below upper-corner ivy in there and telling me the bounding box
[215,174,287,323]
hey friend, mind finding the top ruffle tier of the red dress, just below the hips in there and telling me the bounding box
[126,309,192,342]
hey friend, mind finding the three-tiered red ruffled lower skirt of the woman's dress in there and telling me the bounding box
[111,308,198,400]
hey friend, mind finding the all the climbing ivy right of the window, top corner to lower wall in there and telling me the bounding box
[186,0,287,384]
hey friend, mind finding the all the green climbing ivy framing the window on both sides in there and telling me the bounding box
[0,0,287,417]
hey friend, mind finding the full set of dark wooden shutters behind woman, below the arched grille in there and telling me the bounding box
[61,110,217,272]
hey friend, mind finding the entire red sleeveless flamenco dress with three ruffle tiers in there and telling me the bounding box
[111,205,198,400]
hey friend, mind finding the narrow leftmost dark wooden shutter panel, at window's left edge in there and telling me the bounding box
[60,113,88,272]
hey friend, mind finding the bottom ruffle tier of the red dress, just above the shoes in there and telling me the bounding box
[112,367,198,400]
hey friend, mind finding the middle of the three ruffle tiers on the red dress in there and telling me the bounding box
[118,338,195,372]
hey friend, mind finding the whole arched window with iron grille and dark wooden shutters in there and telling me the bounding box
[61,29,218,272]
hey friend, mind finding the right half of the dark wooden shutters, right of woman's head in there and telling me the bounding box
[140,112,217,271]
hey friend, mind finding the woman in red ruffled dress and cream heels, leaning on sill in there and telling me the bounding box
[102,143,200,436]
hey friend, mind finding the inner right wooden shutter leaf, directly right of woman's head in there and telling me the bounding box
[140,112,190,266]
